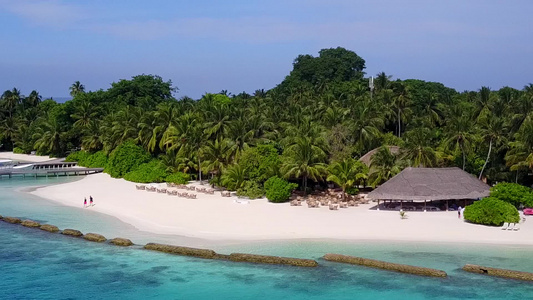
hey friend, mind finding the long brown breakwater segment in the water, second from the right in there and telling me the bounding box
[323,253,448,277]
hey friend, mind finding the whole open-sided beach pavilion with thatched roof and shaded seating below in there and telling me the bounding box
[368,168,490,211]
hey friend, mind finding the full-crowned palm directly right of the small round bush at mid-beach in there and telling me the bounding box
[281,137,326,194]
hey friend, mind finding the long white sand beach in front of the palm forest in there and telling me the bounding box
[32,174,533,245]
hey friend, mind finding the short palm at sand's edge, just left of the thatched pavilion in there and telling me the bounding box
[326,158,368,201]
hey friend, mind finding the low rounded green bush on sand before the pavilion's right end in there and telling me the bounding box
[464,197,520,226]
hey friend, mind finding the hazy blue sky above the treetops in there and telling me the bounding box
[0,0,533,99]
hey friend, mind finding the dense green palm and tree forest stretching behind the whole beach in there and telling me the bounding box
[0,47,533,197]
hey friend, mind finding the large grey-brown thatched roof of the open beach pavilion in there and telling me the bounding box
[368,168,490,201]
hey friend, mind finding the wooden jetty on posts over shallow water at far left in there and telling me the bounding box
[0,159,104,179]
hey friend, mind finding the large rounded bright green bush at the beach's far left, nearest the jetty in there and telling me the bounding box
[105,141,151,178]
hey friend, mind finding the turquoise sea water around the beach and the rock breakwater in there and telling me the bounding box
[0,178,533,300]
